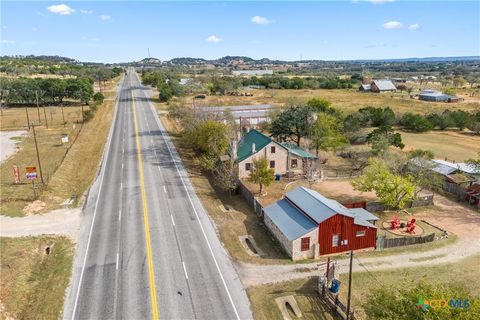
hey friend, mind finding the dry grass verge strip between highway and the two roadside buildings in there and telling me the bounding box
[160,116,291,264]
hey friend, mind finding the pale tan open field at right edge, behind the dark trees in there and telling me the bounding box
[401,131,480,162]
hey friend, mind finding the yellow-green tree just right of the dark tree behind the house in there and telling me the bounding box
[312,112,347,157]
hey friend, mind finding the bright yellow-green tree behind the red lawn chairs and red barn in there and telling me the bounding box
[351,158,415,209]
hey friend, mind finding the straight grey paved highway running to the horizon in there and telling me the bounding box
[63,70,252,319]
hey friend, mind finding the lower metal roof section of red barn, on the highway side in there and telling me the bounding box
[263,199,317,240]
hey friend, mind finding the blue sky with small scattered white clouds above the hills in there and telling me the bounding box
[0,0,480,62]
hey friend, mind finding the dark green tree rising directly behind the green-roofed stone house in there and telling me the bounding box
[270,107,311,146]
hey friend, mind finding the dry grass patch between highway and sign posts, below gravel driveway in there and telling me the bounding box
[247,277,335,320]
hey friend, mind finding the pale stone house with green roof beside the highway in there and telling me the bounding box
[235,129,317,179]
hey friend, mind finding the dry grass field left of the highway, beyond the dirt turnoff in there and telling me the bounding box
[0,79,118,216]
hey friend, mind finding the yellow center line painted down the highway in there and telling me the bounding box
[130,74,159,320]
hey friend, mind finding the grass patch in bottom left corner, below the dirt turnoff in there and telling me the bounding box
[0,236,74,320]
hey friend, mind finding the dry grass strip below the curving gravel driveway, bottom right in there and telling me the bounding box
[340,255,480,319]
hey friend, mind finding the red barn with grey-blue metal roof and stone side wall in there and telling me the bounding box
[263,187,378,260]
